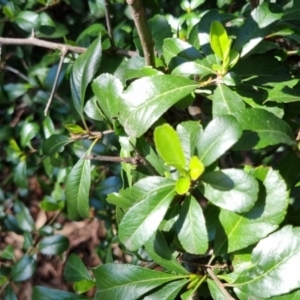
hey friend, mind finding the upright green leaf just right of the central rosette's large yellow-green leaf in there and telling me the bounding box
[176,121,202,168]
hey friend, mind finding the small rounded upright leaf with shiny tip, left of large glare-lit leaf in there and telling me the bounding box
[92,74,123,123]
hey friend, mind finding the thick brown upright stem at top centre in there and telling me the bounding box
[127,0,155,68]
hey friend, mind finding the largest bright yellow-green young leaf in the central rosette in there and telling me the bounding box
[154,124,185,172]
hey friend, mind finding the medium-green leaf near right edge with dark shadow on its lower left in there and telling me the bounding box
[235,108,295,149]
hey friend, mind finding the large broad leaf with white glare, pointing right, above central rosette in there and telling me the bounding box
[119,75,198,137]
